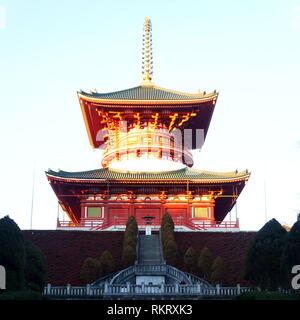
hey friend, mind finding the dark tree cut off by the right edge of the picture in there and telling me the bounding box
[281,221,300,287]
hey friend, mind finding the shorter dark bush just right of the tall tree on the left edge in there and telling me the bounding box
[24,240,47,292]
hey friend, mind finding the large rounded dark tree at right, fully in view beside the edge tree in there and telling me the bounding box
[244,219,287,290]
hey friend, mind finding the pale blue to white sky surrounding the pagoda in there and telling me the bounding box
[0,0,300,230]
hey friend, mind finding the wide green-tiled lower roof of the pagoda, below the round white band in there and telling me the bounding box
[46,168,250,183]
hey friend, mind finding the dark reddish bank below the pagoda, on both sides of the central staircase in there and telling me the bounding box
[23,230,256,286]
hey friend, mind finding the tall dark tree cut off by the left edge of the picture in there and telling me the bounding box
[0,216,25,290]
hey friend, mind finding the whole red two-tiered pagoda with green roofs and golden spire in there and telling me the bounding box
[46,18,249,231]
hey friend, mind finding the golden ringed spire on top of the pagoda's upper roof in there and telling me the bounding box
[142,17,153,85]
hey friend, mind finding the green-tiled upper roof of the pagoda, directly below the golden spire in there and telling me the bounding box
[78,85,218,101]
